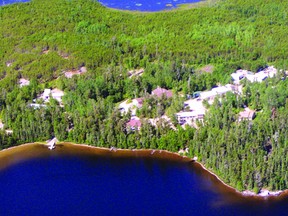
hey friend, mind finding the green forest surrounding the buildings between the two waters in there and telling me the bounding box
[0,0,288,192]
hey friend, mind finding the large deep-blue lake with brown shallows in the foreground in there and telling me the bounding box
[0,144,288,216]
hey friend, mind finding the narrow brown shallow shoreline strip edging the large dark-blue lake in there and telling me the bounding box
[0,142,288,200]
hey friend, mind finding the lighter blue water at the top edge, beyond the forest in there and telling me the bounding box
[0,0,200,11]
